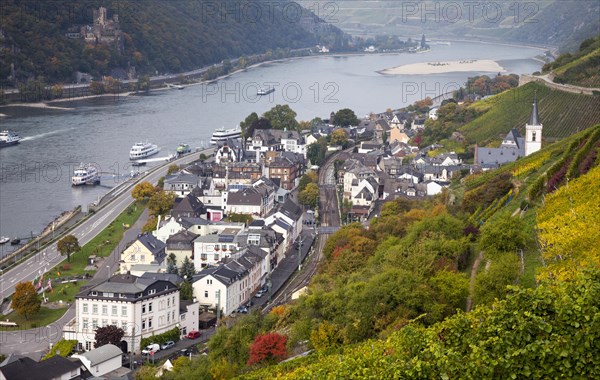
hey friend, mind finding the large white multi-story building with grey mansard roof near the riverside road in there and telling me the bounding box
[63,274,180,352]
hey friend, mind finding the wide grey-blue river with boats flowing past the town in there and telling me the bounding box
[0,42,542,252]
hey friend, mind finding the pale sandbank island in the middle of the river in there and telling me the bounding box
[379,59,506,75]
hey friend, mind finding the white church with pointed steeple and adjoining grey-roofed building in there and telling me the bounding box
[474,96,543,170]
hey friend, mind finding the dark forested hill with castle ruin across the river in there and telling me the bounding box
[0,0,346,85]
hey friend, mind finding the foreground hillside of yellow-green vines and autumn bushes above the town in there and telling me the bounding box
[139,125,600,379]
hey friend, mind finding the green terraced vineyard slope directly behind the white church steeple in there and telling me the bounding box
[459,82,600,145]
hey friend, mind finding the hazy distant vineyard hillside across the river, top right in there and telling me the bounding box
[300,0,600,52]
